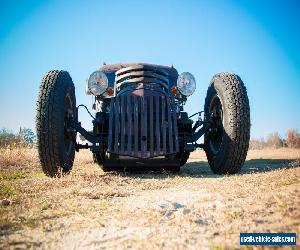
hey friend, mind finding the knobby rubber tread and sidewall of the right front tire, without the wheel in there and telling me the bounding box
[205,72,250,174]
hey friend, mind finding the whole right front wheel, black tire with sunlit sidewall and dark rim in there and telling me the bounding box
[204,73,250,174]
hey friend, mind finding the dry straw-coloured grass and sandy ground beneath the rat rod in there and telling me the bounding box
[0,149,300,249]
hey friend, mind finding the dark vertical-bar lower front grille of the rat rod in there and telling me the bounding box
[108,90,179,158]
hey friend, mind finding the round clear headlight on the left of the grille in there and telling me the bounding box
[88,70,108,95]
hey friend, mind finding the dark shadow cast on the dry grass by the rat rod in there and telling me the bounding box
[123,159,300,179]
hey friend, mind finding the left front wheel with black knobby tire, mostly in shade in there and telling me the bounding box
[36,70,76,177]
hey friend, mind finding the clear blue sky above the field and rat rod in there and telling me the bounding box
[0,0,300,138]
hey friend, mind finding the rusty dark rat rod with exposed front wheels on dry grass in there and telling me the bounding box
[36,63,250,177]
